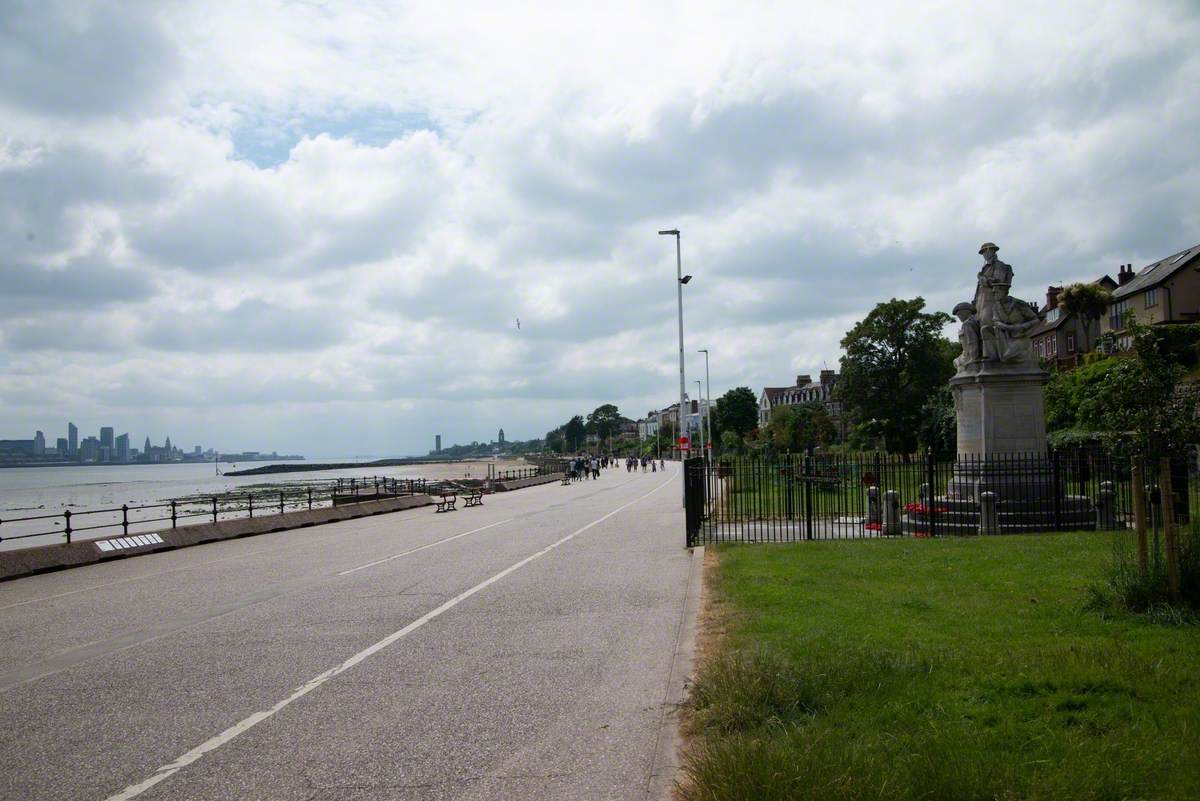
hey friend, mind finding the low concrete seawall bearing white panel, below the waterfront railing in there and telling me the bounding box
[0,495,433,580]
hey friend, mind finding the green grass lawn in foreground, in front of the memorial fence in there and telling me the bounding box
[682,534,1200,801]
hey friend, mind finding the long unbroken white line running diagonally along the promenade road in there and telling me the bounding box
[104,478,673,801]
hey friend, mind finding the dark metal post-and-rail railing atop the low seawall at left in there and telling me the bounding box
[0,476,427,551]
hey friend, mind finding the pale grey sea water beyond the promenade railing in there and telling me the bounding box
[0,458,515,550]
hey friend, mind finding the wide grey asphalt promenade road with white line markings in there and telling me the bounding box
[0,465,697,801]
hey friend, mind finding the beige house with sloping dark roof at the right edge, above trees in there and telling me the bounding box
[1102,245,1200,350]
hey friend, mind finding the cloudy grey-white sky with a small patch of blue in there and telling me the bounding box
[0,0,1200,456]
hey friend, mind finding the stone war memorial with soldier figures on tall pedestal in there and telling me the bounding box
[907,242,1094,534]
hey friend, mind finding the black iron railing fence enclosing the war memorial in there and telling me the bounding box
[684,450,1200,546]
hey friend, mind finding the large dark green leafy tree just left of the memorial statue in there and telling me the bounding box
[838,297,959,453]
